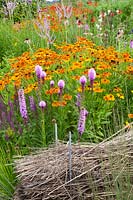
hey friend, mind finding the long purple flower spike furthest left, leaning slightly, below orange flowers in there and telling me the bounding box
[18,89,28,120]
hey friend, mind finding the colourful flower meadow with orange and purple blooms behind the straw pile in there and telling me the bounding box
[0,0,133,200]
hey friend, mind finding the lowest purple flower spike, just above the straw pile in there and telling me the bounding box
[78,108,88,136]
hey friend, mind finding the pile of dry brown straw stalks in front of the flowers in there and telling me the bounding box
[14,129,133,200]
